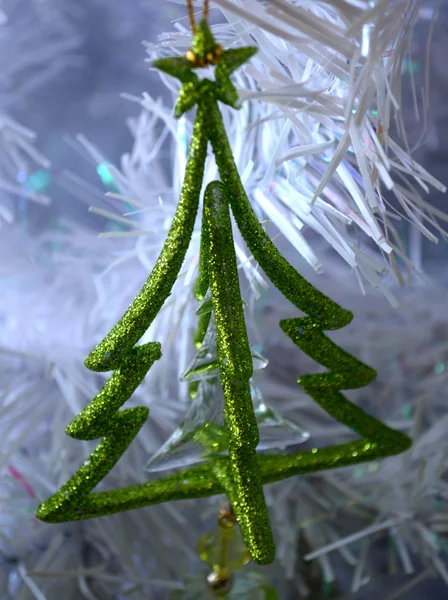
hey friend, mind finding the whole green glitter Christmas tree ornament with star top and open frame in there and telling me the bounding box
[37,12,411,564]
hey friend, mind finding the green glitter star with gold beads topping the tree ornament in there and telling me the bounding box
[153,20,257,118]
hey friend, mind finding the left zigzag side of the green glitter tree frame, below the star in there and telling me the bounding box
[37,103,208,522]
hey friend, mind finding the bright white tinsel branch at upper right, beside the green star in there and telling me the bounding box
[162,0,446,302]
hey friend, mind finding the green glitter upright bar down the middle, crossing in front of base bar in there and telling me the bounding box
[202,182,275,564]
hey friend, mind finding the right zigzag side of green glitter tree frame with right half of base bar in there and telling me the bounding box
[210,94,412,482]
